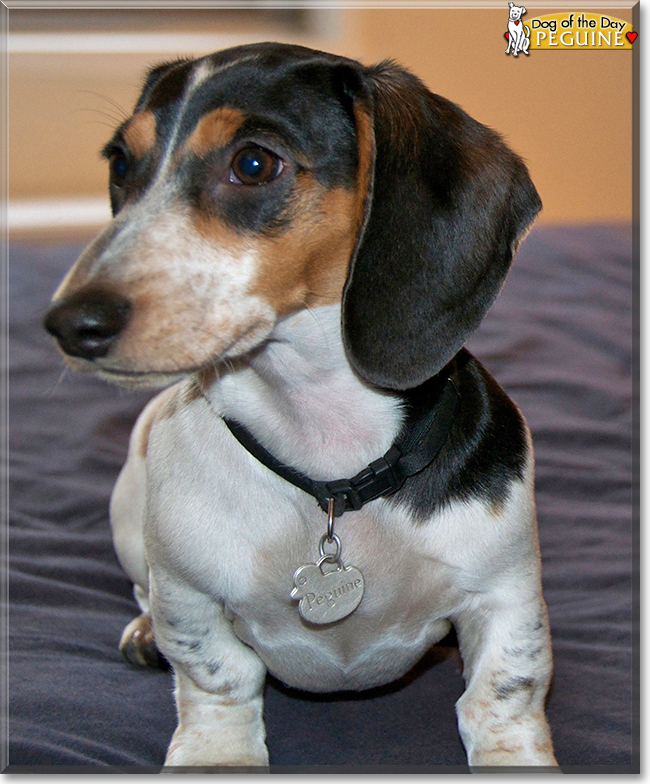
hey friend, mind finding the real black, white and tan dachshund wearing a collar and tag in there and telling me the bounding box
[45,43,558,771]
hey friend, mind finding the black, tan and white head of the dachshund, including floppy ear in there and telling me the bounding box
[45,44,541,389]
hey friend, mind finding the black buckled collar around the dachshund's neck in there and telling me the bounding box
[223,361,460,517]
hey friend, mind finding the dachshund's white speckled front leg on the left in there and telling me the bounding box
[151,570,268,772]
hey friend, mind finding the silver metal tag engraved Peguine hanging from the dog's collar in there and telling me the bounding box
[291,557,364,623]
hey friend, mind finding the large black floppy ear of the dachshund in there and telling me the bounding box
[342,63,541,389]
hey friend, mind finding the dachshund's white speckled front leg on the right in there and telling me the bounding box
[454,584,561,773]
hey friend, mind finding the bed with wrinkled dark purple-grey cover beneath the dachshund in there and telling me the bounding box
[6,225,639,773]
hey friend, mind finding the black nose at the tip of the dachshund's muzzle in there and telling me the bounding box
[43,291,131,359]
